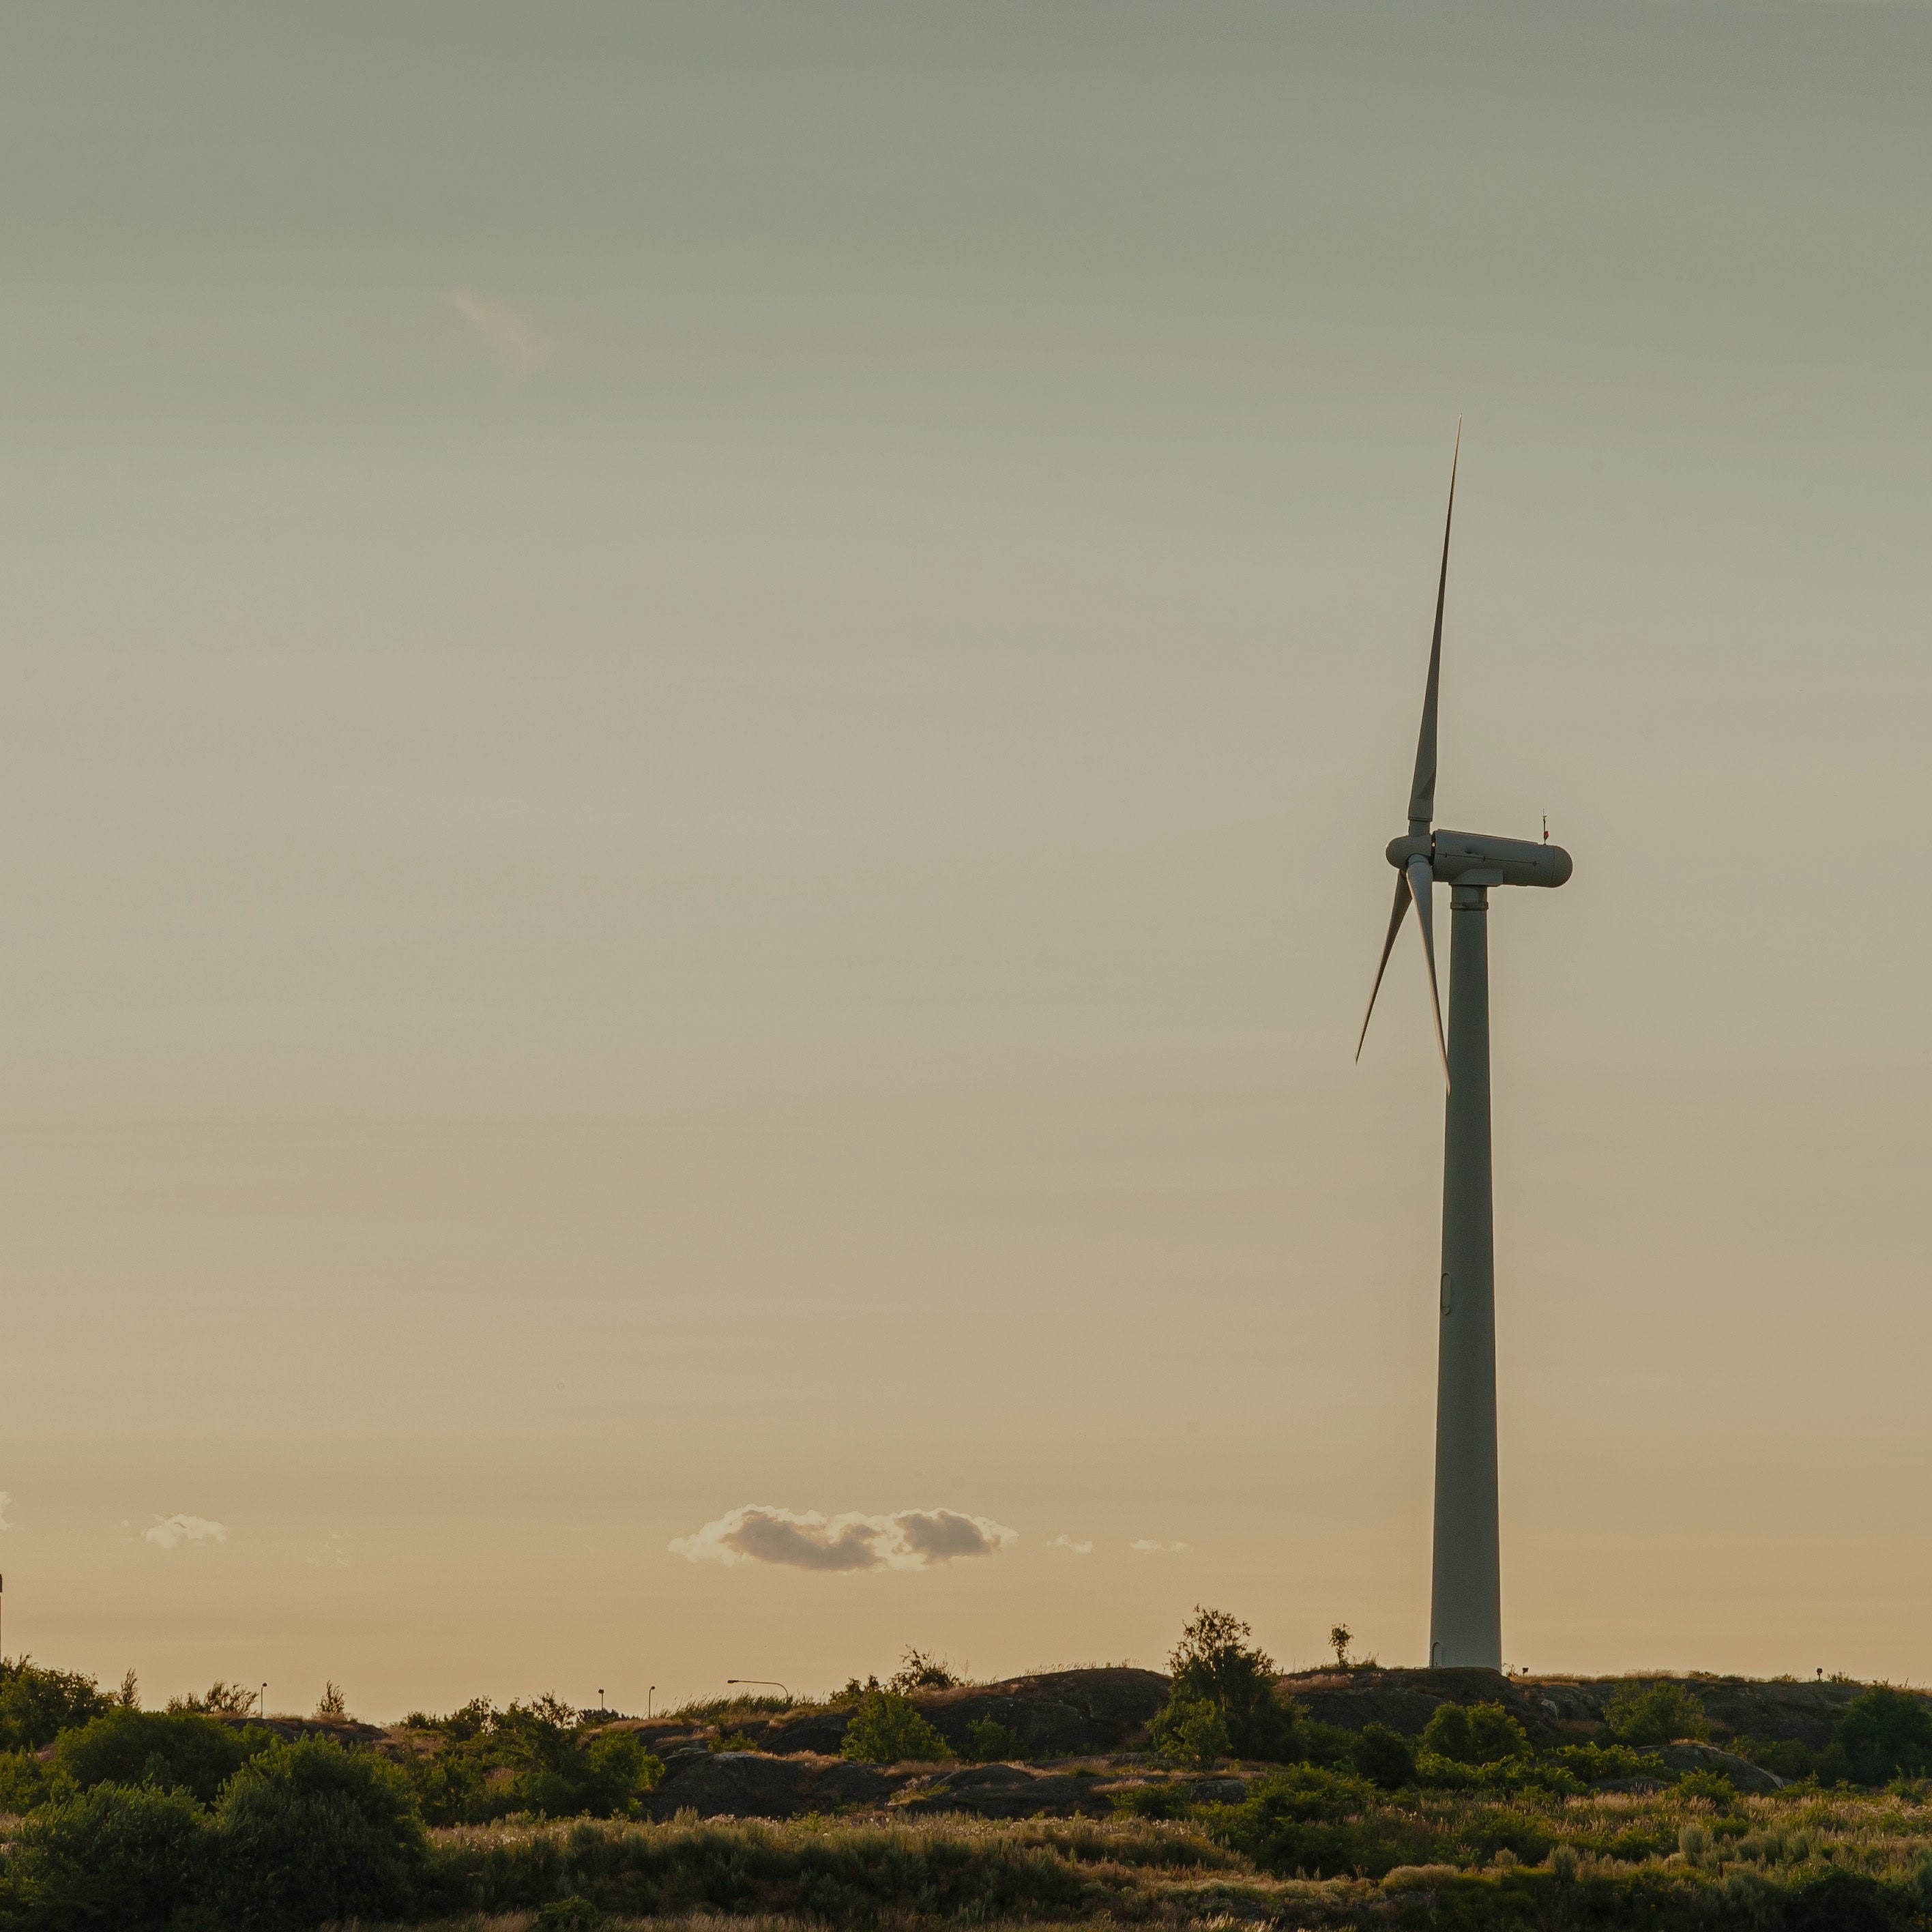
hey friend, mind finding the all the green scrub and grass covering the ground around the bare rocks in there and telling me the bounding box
[0,1638,1932,1932]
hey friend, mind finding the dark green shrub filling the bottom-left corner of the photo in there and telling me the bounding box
[8,1785,211,1932]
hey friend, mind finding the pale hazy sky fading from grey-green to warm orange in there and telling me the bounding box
[0,0,1932,1718]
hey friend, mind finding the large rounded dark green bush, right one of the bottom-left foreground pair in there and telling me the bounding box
[213,1739,429,1932]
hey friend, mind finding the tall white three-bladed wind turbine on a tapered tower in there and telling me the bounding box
[1354,423,1570,1671]
